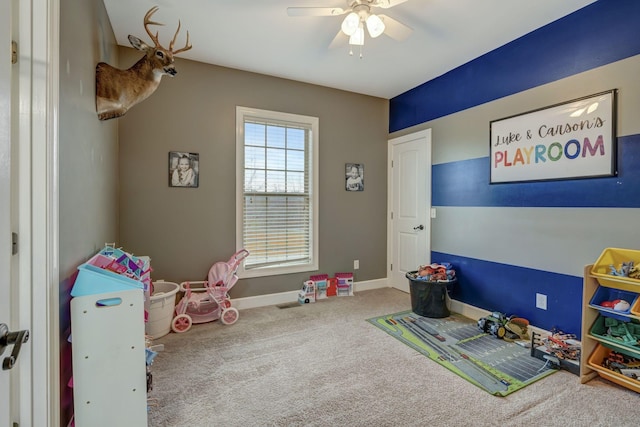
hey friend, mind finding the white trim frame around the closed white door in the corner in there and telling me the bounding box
[387,128,433,289]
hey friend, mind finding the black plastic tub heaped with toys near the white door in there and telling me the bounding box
[406,271,456,318]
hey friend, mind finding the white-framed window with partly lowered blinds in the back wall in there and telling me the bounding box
[236,107,319,277]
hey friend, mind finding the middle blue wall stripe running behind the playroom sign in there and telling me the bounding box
[431,134,640,208]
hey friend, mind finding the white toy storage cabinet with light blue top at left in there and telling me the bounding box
[71,249,147,427]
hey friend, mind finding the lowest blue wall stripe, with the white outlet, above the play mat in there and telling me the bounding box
[431,252,583,336]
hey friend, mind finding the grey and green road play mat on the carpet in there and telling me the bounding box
[367,311,555,396]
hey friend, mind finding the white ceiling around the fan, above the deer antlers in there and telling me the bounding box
[104,0,595,99]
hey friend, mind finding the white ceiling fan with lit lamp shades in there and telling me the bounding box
[287,0,413,57]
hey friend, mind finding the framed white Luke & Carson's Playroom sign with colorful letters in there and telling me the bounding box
[489,89,616,184]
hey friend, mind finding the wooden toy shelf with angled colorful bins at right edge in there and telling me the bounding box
[580,264,640,393]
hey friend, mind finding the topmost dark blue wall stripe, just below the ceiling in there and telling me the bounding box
[389,0,640,133]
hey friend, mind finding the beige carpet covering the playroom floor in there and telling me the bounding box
[149,288,640,427]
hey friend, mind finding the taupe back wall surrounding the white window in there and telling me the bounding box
[119,50,388,298]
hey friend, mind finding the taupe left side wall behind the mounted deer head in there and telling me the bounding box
[58,0,118,426]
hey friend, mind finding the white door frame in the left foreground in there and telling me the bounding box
[16,0,60,427]
